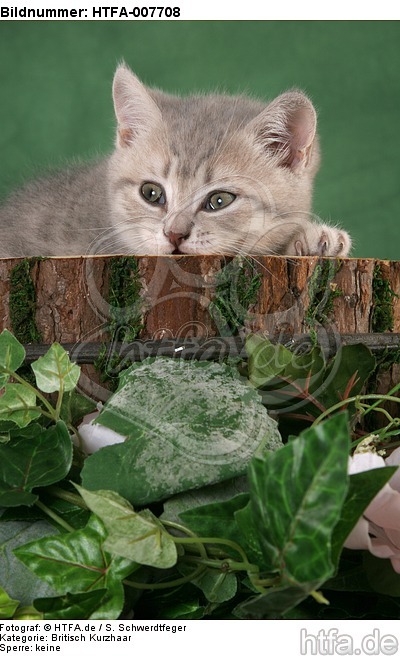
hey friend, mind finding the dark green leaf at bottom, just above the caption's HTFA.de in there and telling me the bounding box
[35,589,107,620]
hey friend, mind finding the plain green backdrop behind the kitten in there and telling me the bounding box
[0,21,400,259]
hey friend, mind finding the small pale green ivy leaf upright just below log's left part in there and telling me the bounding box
[32,342,81,392]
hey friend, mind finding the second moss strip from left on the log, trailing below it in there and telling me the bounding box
[94,256,144,391]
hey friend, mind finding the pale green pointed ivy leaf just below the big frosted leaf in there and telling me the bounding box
[77,486,177,569]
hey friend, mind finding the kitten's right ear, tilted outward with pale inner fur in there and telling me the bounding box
[252,91,317,173]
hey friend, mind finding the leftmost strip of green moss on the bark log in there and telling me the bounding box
[9,258,41,344]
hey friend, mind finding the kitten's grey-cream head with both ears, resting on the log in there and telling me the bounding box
[99,66,319,255]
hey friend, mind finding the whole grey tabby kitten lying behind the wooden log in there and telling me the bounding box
[0,65,351,257]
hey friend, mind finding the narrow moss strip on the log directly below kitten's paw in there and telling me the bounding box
[305,259,342,326]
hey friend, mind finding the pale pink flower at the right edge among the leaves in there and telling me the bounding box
[344,448,400,574]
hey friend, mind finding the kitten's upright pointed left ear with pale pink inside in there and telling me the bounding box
[113,65,161,146]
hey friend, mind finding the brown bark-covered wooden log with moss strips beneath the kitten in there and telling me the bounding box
[0,255,400,400]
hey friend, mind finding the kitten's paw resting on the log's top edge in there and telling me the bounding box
[287,223,351,257]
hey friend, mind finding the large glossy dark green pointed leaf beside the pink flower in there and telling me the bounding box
[249,413,350,587]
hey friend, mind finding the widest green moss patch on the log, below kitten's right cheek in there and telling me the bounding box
[209,257,261,337]
